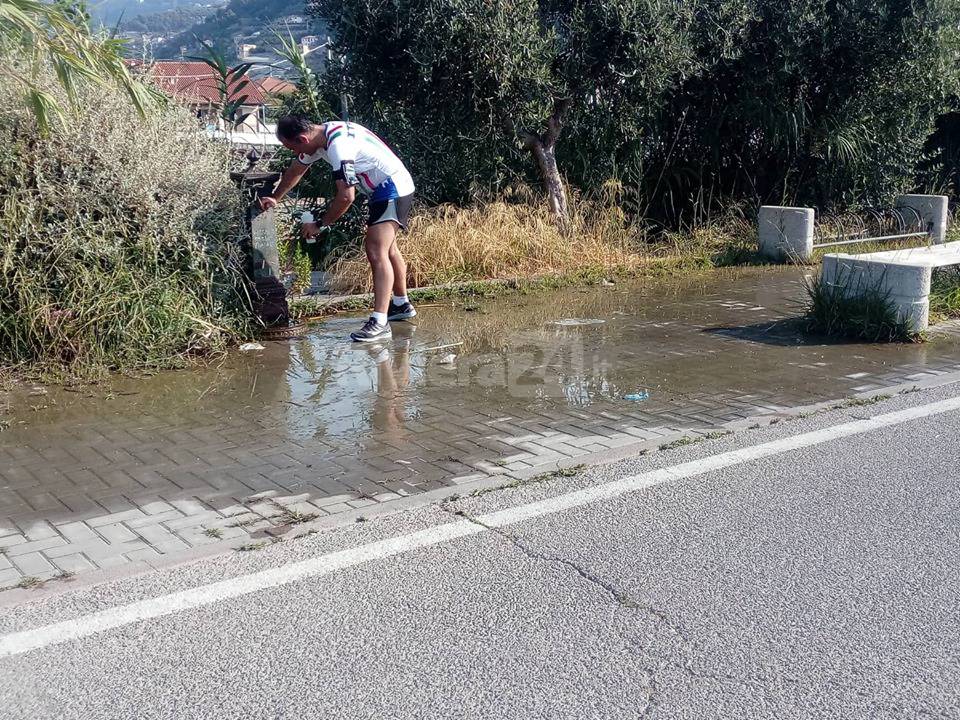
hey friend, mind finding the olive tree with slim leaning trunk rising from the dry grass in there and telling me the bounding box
[310,0,695,217]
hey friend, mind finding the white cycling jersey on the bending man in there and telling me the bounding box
[298,120,415,201]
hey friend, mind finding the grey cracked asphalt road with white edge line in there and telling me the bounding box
[0,386,960,720]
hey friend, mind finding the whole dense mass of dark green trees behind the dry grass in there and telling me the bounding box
[309,0,960,225]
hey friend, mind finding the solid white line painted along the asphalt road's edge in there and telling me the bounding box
[0,397,960,657]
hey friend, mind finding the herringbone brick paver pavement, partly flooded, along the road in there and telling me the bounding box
[0,269,960,586]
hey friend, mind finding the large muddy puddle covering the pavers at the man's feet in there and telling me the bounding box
[4,269,960,430]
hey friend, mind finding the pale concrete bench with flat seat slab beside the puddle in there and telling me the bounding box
[821,242,960,332]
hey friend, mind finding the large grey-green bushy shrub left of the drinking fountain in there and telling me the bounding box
[0,60,249,371]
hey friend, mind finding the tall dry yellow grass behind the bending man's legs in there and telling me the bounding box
[331,197,756,293]
